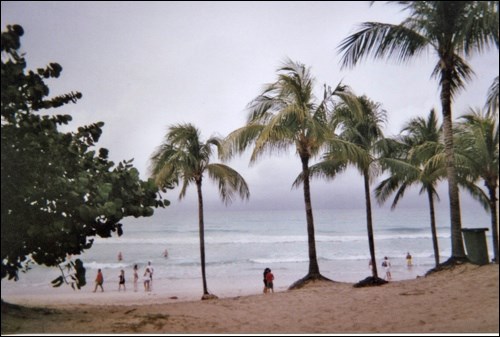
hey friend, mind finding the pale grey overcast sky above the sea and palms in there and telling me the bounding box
[1,1,499,213]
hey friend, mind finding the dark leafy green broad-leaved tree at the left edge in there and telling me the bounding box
[1,25,168,286]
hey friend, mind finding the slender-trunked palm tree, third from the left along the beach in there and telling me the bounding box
[330,96,386,283]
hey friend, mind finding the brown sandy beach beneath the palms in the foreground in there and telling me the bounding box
[2,264,499,334]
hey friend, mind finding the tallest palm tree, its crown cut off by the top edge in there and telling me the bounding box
[339,1,498,262]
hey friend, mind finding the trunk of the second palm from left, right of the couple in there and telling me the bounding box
[301,156,321,278]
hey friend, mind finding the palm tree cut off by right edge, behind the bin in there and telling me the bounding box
[456,110,499,263]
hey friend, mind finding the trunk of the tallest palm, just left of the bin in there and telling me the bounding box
[441,65,467,261]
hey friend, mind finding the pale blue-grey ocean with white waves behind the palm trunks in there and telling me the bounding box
[2,207,492,298]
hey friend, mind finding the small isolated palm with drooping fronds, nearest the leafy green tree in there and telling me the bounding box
[150,124,250,299]
